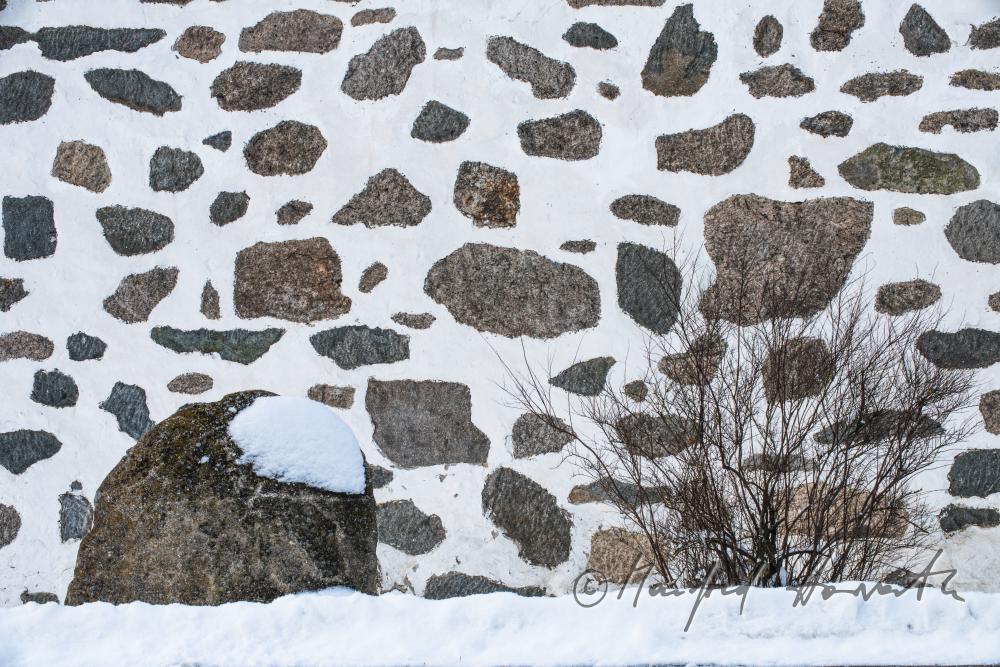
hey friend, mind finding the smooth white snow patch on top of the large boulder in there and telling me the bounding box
[229,396,365,494]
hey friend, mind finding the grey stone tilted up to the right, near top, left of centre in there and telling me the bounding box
[340,27,427,101]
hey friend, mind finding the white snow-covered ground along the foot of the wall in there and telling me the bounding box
[0,584,1000,667]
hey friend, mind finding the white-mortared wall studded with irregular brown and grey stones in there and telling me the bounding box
[0,0,1000,605]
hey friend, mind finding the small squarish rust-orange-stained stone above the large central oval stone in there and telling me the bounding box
[453,162,521,227]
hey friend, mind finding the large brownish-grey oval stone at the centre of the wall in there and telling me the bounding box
[424,243,601,338]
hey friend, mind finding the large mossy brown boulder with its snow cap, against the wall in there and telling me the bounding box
[66,391,378,605]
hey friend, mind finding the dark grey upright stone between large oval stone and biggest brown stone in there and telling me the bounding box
[615,243,683,334]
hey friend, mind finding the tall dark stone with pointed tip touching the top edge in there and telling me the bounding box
[642,4,719,97]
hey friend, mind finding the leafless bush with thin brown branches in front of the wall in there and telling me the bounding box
[507,253,975,586]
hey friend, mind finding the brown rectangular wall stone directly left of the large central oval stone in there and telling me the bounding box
[233,237,351,322]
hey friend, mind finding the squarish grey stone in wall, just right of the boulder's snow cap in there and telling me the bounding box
[365,379,490,469]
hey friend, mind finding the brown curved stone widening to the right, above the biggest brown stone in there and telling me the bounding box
[656,114,755,176]
